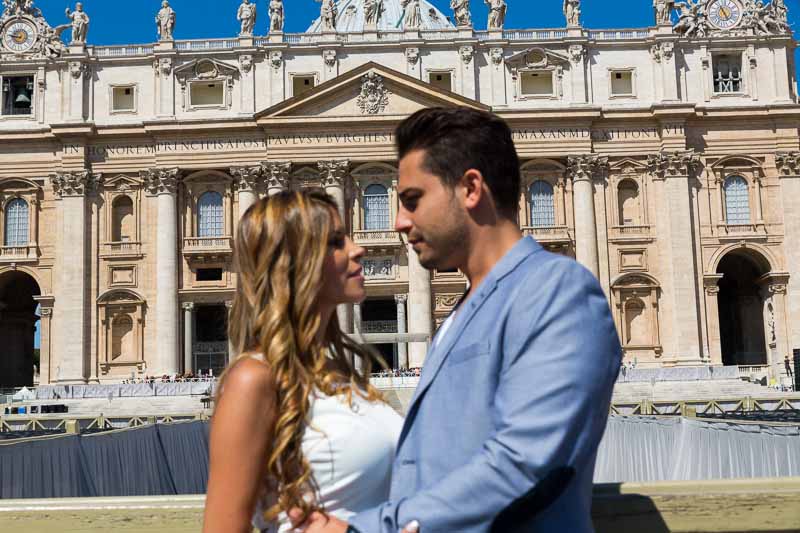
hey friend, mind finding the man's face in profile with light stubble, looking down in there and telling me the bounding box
[395,150,468,270]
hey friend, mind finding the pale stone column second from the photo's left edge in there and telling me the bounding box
[141,168,181,375]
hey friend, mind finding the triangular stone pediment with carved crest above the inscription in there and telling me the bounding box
[256,62,489,123]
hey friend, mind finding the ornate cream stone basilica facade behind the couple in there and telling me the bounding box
[0,0,800,386]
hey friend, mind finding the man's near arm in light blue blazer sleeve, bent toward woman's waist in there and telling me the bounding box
[350,260,620,533]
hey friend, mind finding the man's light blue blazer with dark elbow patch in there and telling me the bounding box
[349,238,621,533]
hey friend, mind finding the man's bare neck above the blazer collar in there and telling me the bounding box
[461,220,522,295]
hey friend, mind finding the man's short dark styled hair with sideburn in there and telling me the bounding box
[396,107,520,220]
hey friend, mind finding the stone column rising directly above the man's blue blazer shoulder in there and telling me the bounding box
[568,155,608,278]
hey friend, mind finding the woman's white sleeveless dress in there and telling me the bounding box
[253,378,403,533]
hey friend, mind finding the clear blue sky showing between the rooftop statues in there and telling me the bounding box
[36,0,800,45]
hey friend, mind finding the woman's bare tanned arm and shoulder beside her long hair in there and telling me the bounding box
[203,359,276,533]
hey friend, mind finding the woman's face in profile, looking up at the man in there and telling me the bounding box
[320,213,367,306]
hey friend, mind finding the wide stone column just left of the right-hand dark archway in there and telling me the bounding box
[648,151,706,366]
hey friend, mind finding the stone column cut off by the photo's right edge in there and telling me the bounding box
[775,152,800,358]
